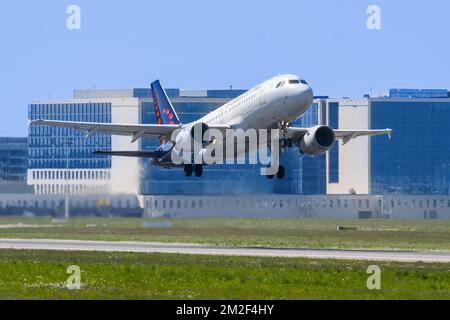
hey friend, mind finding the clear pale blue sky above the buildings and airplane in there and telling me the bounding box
[0,0,450,136]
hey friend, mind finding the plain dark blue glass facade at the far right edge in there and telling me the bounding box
[370,98,450,195]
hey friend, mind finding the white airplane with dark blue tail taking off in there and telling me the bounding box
[31,74,392,179]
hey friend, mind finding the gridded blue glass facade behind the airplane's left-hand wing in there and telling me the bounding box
[28,102,111,169]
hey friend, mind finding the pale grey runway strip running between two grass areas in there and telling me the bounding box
[0,239,450,263]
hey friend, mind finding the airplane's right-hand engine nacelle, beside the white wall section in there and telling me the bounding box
[300,126,336,157]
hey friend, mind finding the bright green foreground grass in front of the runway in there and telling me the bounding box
[0,250,450,300]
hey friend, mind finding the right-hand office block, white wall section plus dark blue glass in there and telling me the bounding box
[327,89,450,195]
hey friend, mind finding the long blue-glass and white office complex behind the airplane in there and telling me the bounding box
[28,85,450,200]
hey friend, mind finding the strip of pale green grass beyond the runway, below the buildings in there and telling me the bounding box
[0,218,450,251]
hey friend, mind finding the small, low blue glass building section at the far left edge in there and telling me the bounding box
[0,138,28,183]
